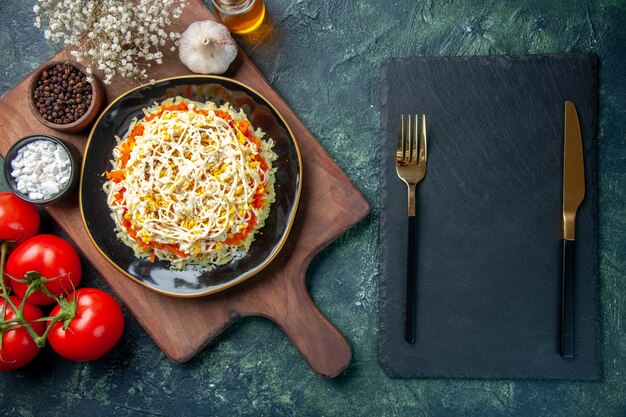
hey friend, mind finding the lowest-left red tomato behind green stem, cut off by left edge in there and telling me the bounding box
[0,297,46,372]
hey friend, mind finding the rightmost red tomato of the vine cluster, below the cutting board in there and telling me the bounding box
[48,288,124,362]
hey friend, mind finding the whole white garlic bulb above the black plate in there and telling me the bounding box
[178,20,237,74]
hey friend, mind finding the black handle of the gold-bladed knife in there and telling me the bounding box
[561,239,576,358]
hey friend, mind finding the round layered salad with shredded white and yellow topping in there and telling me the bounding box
[104,98,276,268]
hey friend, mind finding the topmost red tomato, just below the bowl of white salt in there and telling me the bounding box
[0,192,39,244]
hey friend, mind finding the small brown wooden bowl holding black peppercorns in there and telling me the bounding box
[28,61,104,133]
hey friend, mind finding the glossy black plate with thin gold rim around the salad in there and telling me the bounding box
[80,75,302,297]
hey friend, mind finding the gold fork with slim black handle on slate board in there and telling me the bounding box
[396,114,427,343]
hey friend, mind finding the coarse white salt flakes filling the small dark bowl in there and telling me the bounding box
[11,140,71,200]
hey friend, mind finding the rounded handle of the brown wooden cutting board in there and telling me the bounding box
[256,276,352,378]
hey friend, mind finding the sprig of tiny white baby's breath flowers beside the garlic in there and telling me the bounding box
[33,0,188,84]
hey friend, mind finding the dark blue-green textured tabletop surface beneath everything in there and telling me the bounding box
[0,0,626,416]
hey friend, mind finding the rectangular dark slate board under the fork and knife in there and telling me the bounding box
[379,54,602,380]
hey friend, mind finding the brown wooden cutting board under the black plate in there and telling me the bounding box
[0,0,369,377]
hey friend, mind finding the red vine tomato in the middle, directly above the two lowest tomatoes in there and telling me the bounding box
[5,235,82,305]
